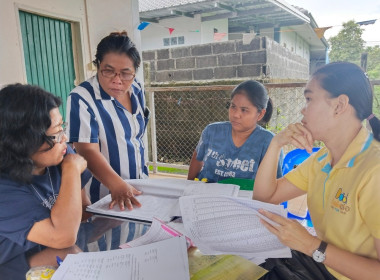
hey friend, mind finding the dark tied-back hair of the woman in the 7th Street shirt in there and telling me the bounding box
[231,80,273,126]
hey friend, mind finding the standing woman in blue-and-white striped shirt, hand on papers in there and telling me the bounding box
[67,32,149,209]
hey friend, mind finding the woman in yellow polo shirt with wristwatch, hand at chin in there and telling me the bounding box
[253,62,380,279]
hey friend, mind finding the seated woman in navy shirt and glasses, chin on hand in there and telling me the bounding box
[0,84,91,280]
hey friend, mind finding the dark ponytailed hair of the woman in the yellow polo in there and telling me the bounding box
[312,62,380,141]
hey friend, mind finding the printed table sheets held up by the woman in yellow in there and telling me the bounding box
[179,195,291,259]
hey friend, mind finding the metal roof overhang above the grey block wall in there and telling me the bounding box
[139,0,310,32]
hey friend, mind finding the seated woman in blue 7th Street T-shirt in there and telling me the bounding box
[187,80,283,185]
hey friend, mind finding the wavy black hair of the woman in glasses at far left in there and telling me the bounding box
[0,84,61,183]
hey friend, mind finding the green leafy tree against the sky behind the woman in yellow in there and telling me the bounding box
[329,20,364,65]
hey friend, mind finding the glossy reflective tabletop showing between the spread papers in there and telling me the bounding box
[78,216,266,280]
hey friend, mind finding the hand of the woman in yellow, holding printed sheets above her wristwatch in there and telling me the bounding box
[259,209,321,256]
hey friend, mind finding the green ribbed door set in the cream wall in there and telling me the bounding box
[19,11,75,120]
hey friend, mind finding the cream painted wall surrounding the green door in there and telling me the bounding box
[0,0,142,87]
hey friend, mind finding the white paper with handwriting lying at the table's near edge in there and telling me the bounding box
[52,236,190,280]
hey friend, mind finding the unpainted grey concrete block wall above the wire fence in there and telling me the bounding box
[143,37,309,85]
